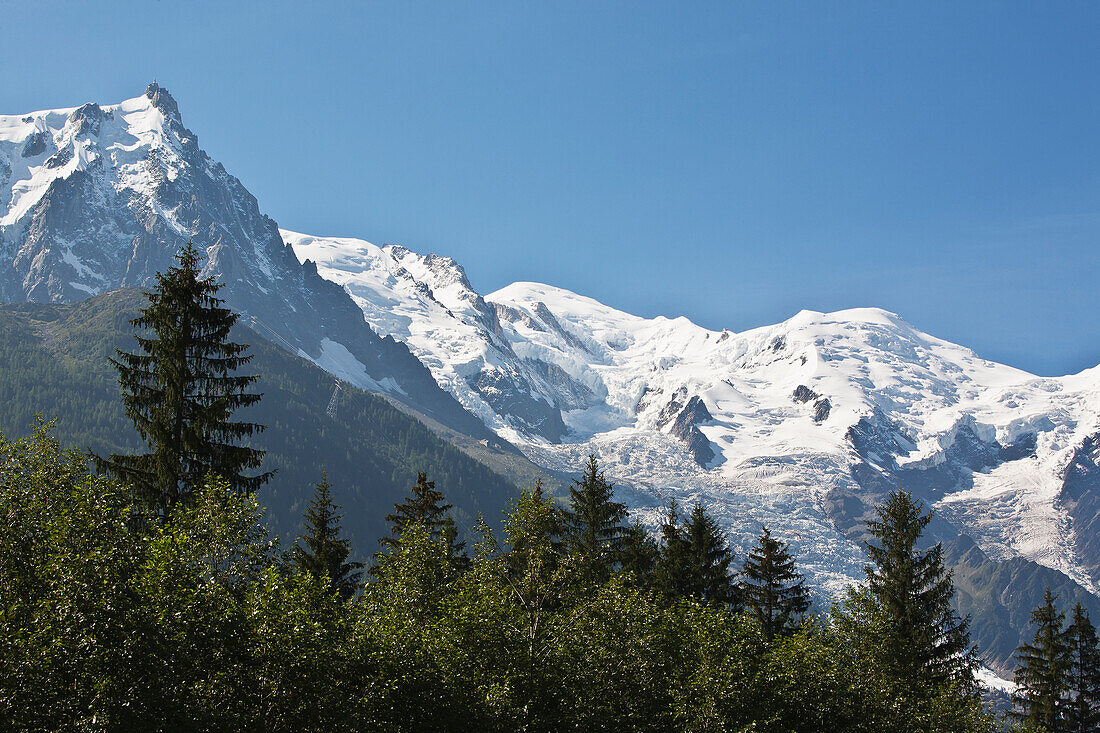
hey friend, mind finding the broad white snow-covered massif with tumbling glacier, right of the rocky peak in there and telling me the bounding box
[290,231,1100,669]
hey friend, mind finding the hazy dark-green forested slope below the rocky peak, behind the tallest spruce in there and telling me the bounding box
[0,289,517,555]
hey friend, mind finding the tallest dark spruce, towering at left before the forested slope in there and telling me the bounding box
[97,242,272,516]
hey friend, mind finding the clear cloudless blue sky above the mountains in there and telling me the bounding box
[0,0,1100,374]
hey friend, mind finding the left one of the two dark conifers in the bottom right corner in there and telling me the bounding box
[1012,588,1073,733]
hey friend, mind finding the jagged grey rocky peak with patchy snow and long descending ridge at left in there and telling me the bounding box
[0,83,491,438]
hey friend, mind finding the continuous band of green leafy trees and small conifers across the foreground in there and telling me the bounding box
[0,426,993,731]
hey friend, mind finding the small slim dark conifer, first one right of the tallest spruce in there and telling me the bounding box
[293,472,363,599]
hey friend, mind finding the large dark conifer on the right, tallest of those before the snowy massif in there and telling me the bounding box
[866,491,977,689]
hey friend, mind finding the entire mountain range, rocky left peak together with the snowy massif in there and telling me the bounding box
[0,84,1100,670]
